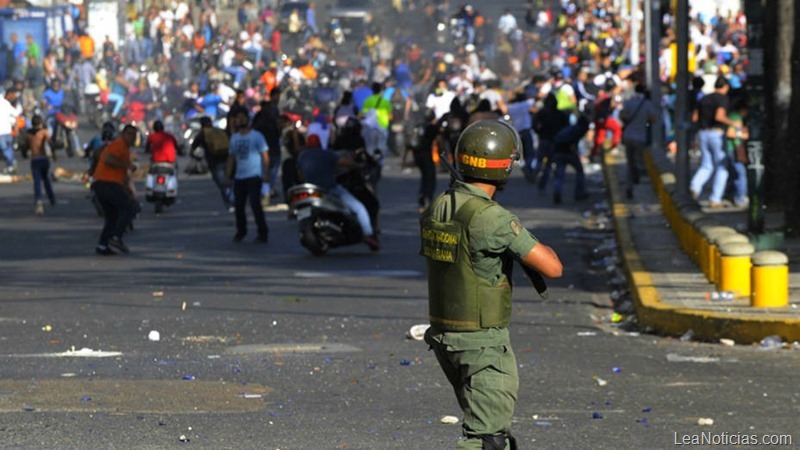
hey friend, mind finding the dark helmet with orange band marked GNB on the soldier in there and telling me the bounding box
[455,120,522,182]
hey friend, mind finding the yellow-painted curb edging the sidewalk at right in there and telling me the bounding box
[603,149,800,343]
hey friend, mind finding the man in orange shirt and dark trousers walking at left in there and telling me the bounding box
[92,125,137,256]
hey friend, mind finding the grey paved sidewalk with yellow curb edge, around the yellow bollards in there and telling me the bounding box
[604,146,800,343]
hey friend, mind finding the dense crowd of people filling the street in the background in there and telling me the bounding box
[0,0,747,243]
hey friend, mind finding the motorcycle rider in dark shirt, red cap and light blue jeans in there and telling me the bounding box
[297,134,380,252]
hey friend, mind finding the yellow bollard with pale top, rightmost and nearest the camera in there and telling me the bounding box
[750,250,789,308]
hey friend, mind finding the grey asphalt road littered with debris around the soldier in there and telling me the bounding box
[0,142,800,449]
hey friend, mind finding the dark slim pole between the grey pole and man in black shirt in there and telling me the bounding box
[675,0,689,194]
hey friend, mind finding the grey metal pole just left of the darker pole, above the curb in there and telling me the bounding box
[644,0,664,155]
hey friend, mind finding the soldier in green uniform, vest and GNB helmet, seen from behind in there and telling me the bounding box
[420,120,562,450]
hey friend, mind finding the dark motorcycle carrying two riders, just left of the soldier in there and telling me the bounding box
[287,183,364,256]
